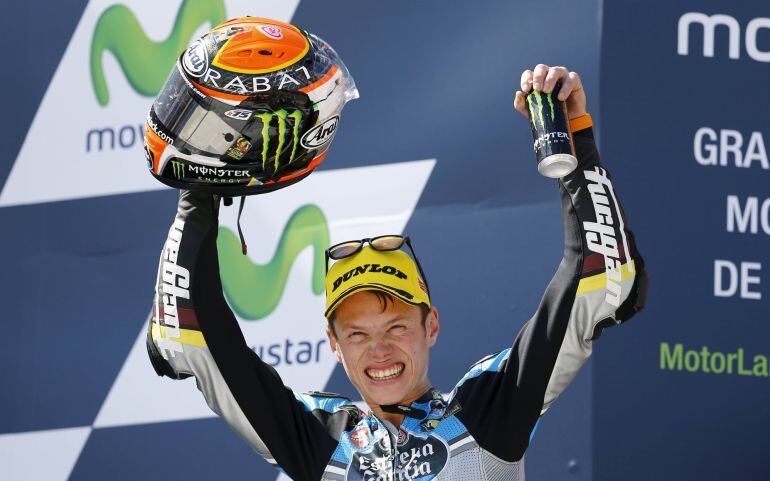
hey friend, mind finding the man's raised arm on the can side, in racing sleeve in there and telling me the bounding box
[448,63,646,461]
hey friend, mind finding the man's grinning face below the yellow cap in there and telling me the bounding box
[327,291,439,405]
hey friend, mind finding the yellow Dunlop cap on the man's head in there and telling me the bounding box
[326,246,430,318]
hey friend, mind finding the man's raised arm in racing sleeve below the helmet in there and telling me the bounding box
[147,191,344,480]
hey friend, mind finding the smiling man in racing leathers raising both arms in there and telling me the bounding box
[142,16,646,481]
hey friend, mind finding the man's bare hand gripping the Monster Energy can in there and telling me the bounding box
[513,63,586,119]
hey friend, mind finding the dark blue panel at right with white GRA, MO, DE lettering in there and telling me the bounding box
[594,0,770,481]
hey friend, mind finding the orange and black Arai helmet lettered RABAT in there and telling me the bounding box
[144,17,358,196]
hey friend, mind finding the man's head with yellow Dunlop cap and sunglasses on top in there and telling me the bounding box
[326,235,439,418]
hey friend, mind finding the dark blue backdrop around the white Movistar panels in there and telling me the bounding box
[0,0,770,481]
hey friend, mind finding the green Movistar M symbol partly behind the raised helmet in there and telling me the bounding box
[91,0,227,106]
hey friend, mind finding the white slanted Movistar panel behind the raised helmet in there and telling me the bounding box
[0,0,299,206]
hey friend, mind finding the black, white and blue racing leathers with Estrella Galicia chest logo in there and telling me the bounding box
[147,121,646,481]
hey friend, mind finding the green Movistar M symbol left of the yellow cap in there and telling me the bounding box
[217,204,329,321]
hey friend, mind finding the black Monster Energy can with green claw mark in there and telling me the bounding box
[527,84,577,179]
